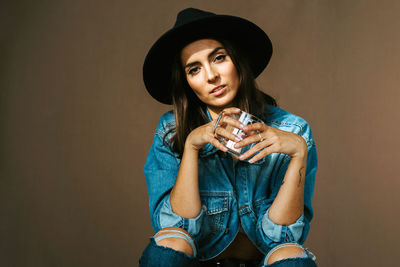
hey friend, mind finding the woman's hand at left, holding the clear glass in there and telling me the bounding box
[185,108,244,152]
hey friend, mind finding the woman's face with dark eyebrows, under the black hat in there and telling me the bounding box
[181,39,239,115]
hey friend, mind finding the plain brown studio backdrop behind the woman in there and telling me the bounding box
[0,0,400,266]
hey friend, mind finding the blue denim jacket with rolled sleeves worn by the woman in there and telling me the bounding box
[144,106,317,260]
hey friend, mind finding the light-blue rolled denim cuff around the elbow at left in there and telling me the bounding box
[159,196,204,236]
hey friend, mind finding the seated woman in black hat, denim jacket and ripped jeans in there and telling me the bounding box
[140,8,317,266]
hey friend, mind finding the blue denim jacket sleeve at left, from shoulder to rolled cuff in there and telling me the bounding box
[144,117,204,236]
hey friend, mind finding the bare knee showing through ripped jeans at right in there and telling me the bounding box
[265,243,309,265]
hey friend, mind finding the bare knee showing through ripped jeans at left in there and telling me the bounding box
[154,227,196,256]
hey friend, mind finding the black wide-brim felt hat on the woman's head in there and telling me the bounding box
[143,8,272,104]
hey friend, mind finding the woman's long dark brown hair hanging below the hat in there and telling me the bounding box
[164,38,277,155]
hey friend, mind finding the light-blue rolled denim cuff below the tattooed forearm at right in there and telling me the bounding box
[262,209,305,243]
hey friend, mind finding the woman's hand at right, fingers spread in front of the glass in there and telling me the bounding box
[235,123,307,163]
